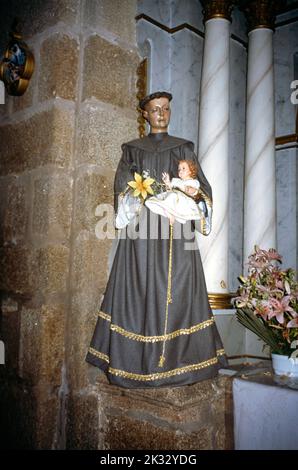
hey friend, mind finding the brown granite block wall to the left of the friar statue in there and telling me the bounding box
[0,0,140,449]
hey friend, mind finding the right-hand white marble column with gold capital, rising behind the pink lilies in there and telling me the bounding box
[243,0,276,268]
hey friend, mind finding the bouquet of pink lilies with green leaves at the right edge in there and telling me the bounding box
[233,246,298,358]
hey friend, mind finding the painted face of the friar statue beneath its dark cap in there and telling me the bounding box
[143,97,171,134]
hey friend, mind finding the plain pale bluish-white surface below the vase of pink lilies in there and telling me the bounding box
[233,378,298,450]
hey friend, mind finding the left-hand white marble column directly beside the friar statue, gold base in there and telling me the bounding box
[199,0,232,308]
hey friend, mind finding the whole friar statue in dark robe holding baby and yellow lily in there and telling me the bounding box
[87,91,227,388]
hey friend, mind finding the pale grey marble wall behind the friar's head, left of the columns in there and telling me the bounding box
[137,1,203,148]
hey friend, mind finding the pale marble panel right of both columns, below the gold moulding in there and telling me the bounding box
[276,148,298,269]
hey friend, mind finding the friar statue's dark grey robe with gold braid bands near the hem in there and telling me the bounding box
[86,133,227,388]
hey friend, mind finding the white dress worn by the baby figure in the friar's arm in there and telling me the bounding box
[145,178,204,224]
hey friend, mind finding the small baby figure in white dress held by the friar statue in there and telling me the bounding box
[145,160,204,224]
